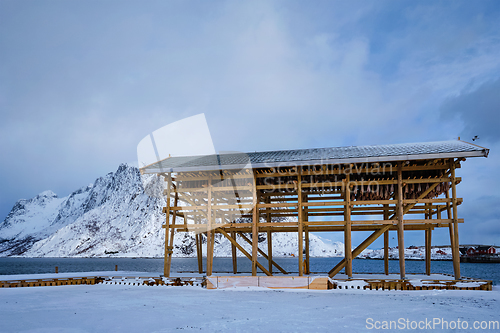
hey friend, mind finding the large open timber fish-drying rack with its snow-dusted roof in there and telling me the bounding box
[141,140,489,280]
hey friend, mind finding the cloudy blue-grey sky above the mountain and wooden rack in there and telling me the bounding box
[0,0,500,245]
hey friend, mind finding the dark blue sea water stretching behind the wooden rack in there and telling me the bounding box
[0,258,500,285]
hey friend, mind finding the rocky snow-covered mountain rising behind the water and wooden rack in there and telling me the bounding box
[0,164,344,257]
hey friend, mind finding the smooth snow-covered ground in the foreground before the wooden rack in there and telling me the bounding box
[0,285,500,333]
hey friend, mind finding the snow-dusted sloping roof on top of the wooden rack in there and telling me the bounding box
[142,140,489,173]
